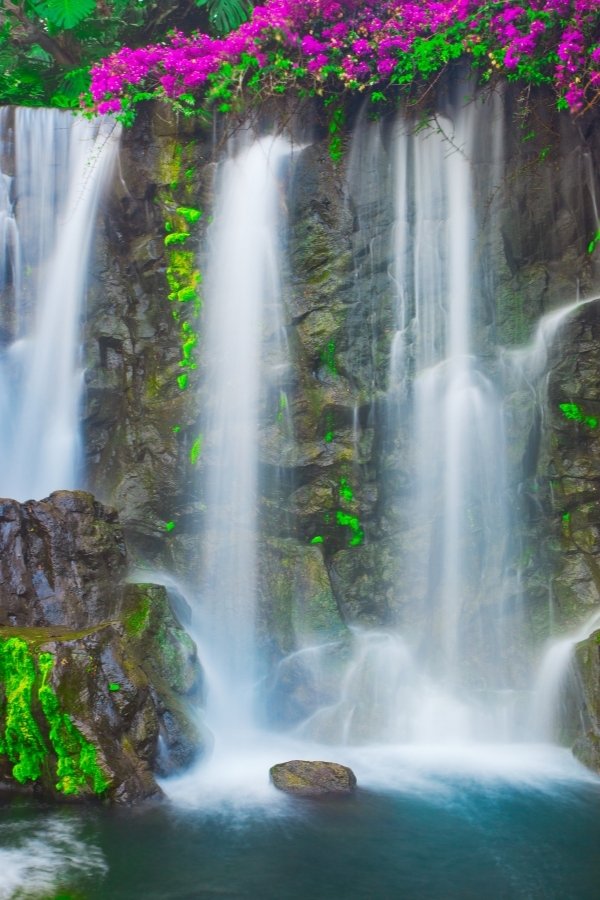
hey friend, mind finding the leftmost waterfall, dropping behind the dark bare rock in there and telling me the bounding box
[0,109,119,500]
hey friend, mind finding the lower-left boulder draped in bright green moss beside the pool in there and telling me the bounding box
[0,585,207,803]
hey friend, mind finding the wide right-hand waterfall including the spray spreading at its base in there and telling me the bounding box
[292,99,521,743]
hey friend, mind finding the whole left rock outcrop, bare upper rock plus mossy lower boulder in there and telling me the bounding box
[0,491,207,803]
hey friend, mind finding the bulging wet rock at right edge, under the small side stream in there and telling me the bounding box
[523,301,600,629]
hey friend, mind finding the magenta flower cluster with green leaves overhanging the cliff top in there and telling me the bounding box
[91,0,600,113]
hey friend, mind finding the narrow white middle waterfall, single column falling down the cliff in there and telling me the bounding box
[197,135,291,735]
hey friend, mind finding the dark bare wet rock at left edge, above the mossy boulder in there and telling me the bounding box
[0,491,126,629]
